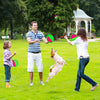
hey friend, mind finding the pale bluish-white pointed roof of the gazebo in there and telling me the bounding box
[73,9,93,19]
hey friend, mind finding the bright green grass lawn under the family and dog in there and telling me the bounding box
[0,40,100,100]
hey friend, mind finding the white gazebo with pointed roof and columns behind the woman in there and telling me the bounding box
[67,9,93,37]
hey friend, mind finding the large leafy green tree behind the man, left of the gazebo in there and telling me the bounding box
[26,0,77,39]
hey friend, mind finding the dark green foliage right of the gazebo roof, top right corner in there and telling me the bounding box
[78,0,100,34]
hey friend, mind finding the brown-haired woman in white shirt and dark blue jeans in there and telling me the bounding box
[64,28,98,91]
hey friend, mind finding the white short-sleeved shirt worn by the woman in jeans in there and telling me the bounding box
[71,37,89,58]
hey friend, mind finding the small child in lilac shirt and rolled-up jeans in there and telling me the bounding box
[3,41,16,88]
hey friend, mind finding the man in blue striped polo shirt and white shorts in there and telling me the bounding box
[26,21,48,86]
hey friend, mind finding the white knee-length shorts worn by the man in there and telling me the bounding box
[27,52,43,72]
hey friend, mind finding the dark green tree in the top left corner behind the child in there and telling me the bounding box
[0,0,27,39]
